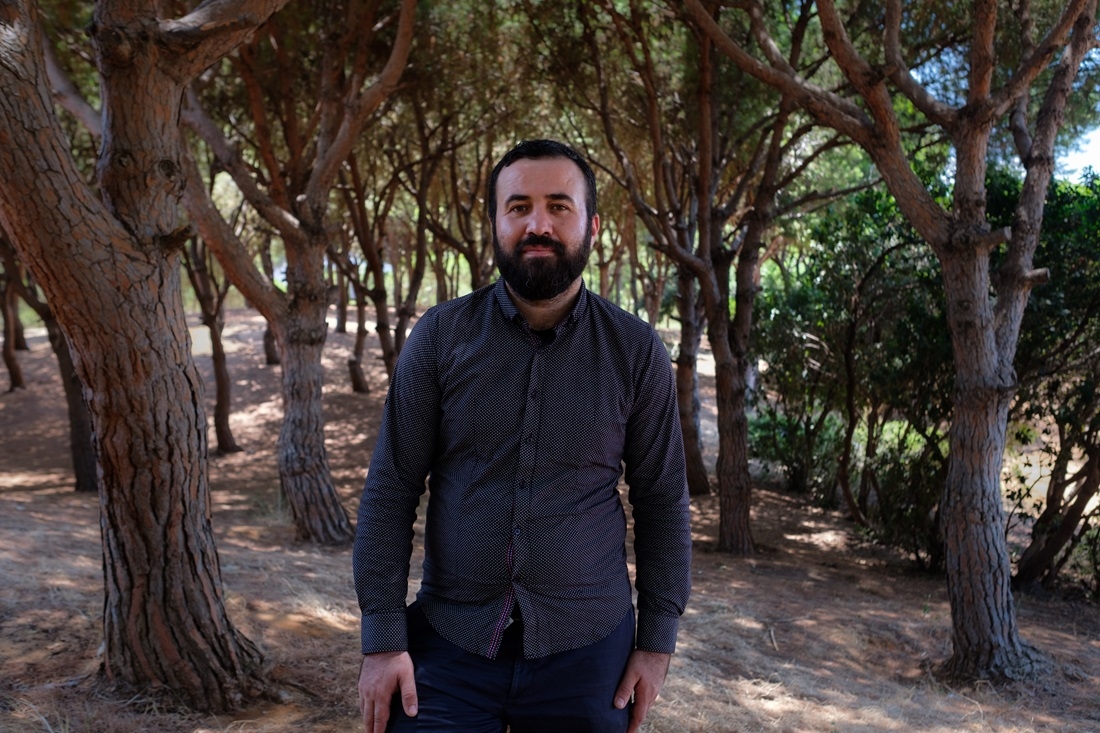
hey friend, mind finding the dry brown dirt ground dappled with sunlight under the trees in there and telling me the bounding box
[0,311,1100,733]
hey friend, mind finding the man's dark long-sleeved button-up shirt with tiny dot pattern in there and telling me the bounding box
[353,280,691,658]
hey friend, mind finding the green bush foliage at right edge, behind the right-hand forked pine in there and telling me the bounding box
[988,169,1100,584]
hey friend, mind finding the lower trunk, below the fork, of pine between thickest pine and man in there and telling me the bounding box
[275,244,354,545]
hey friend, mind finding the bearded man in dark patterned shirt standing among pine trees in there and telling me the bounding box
[353,140,691,733]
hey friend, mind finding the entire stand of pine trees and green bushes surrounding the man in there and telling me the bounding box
[0,0,1100,709]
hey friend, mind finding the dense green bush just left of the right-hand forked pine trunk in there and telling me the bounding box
[752,190,953,559]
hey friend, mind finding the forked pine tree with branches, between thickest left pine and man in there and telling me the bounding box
[184,0,416,545]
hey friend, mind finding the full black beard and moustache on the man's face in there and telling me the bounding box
[493,229,592,300]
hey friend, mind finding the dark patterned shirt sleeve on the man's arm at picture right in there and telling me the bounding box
[624,333,691,654]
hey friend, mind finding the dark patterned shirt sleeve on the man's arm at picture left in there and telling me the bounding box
[352,311,440,654]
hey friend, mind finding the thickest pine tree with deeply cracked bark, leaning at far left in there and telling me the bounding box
[0,0,299,710]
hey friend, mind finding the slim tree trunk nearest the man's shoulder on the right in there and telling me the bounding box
[675,271,711,496]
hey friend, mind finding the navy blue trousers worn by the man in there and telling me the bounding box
[386,603,634,733]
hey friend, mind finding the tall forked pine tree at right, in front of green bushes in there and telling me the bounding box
[688,0,1097,679]
